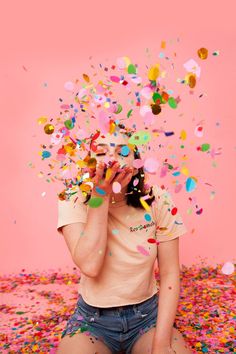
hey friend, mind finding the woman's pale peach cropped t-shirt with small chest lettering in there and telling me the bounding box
[57,185,187,307]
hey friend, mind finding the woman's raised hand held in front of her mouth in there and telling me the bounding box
[89,161,133,196]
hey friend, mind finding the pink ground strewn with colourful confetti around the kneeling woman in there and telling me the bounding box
[0,264,236,354]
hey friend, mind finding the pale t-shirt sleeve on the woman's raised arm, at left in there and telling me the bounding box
[57,188,87,235]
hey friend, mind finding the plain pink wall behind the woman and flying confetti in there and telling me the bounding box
[0,0,236,273]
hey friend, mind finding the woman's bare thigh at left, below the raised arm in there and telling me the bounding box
[56,333,112,354]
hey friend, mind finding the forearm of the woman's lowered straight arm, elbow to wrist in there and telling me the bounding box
[153,272,180,346]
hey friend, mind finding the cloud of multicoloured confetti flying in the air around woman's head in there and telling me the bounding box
[33,48,222,227]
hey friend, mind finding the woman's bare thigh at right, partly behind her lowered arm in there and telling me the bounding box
[131,327,192,354]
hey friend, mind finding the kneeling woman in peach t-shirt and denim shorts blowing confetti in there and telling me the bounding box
[57,131,191,354]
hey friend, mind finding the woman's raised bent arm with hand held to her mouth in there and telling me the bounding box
[62,163,132,277]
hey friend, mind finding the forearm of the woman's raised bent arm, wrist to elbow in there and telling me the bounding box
[73,197,109,274]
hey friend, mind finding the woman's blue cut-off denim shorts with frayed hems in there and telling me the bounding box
[61,293,164,354]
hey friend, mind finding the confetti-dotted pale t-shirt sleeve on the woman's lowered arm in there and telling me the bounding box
[152,185,188,242]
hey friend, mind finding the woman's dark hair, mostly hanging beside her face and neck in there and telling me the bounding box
[79,124,155,209]
